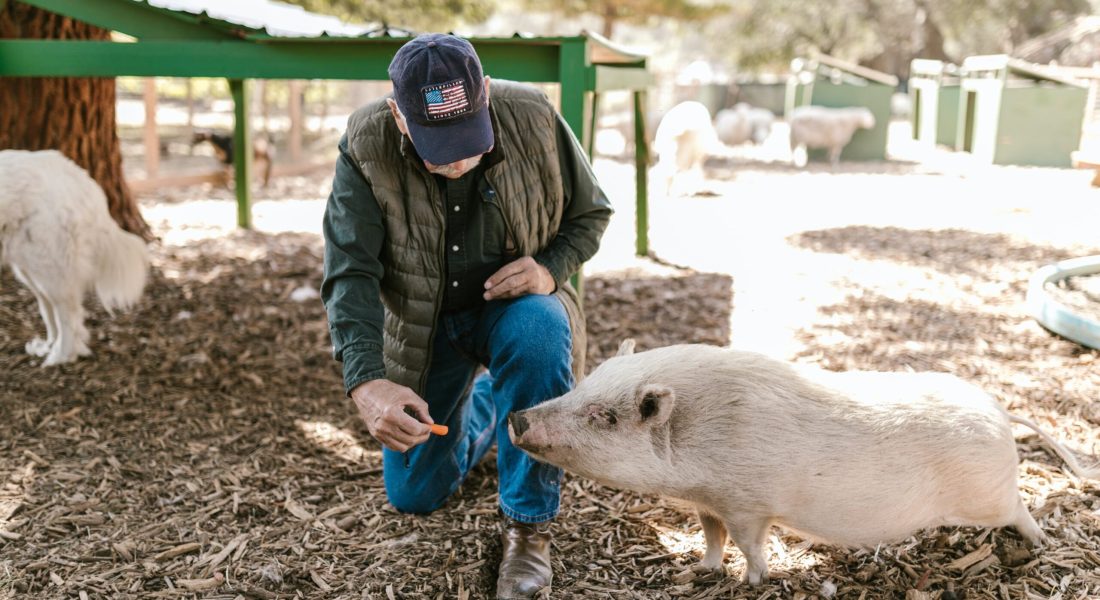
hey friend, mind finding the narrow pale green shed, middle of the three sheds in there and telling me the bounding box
[909,58,959,148]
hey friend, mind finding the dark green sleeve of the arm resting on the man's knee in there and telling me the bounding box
[535,114,613,286]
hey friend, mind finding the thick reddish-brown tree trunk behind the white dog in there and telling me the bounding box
[0,1,152,239]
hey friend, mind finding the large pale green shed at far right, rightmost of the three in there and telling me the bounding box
[955,55,1088,166]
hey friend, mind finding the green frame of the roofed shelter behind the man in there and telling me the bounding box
[0,0,652,262]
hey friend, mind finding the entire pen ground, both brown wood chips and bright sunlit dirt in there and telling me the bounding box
[0,132,1100,600]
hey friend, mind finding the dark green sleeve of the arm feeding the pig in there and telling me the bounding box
[321,135,386,394]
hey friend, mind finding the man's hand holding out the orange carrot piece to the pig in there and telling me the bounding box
[351,379,435,452]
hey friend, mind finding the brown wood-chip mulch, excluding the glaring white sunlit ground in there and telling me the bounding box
[0,212,1100,600]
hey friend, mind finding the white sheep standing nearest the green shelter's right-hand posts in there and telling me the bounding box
[653,100,719,192]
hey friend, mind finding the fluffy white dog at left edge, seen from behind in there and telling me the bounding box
[0,150,149,367]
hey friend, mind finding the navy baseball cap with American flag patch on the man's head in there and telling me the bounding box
[389,33,493,165]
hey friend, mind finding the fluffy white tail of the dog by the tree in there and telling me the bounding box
[95,221,149,313]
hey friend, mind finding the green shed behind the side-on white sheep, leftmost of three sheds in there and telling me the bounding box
[783,54,898,161]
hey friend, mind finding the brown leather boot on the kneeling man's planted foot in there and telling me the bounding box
[496,517,553,600]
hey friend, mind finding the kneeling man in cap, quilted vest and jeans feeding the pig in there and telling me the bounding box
[321,34,612,598]
